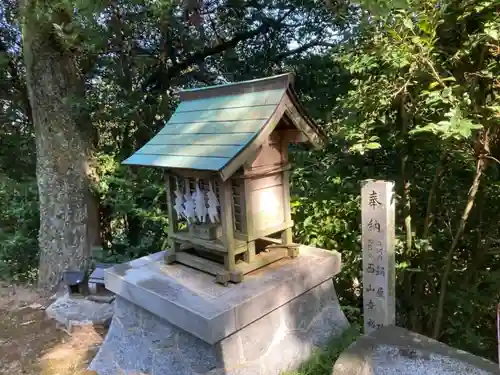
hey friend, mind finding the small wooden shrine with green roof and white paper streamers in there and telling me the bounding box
[124,74,325,284]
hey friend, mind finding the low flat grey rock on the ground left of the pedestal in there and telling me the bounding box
[45,294,113,328]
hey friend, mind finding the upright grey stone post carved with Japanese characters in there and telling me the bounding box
[361,180,396,334]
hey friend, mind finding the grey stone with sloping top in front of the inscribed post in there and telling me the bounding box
[332,326,500,375]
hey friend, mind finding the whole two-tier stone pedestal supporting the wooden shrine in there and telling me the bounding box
[89,247,348,375]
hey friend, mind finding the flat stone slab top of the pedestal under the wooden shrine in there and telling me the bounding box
[104,245,340,344]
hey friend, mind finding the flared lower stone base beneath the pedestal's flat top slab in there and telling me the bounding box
[89,279,349,375]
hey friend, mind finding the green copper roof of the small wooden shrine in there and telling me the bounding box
[123,74,326,181]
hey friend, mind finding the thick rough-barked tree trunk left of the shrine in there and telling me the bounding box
[22,0,98,289]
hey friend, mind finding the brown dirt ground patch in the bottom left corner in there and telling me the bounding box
[0,283,106,375]
